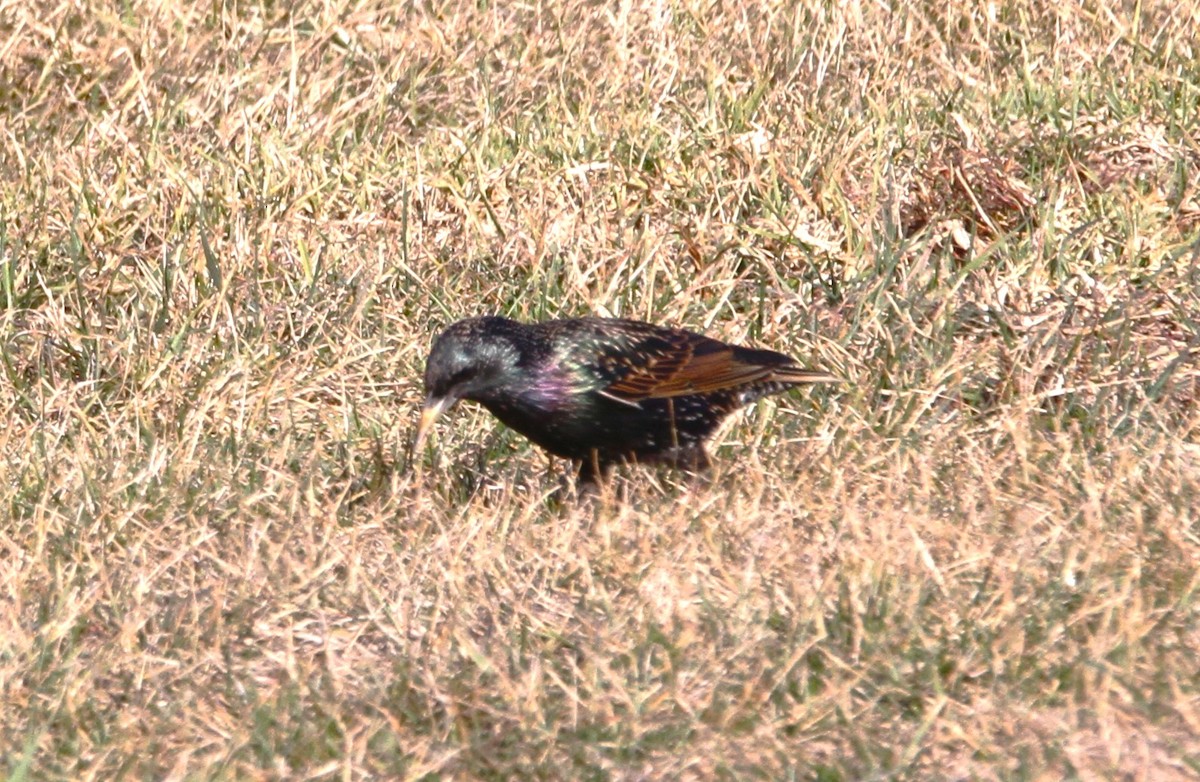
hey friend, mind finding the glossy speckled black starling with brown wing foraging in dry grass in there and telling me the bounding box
[416,317,838,483]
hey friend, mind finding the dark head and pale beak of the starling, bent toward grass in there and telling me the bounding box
[413,317,520,450]
